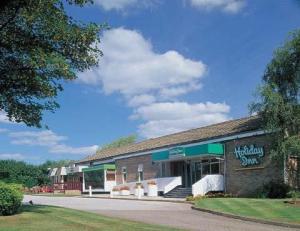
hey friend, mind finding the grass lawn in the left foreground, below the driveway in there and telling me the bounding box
[0,205,180,231]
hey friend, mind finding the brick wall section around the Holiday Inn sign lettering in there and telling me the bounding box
[225,135,283,196]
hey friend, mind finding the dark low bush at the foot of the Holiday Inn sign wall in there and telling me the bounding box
[262,181,290,199]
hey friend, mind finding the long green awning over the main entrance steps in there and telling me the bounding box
[152,144,224,161]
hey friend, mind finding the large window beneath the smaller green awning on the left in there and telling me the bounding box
[84,169,104,189]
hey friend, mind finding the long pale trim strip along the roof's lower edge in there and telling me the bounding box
[112,130,268,161]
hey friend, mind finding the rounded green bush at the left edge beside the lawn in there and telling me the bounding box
[0,182,23,216]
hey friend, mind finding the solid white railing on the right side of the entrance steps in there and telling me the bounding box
[192,174,224,196]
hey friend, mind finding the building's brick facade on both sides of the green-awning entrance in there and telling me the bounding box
[116,136,283,196]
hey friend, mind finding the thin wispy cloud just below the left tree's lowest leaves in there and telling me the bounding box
[9,130,67,146]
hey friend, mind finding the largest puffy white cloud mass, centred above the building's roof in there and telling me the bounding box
[79,28,230,138]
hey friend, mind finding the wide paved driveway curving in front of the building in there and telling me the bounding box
[24,196,297,231]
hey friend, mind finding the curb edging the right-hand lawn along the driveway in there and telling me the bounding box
[191,206,300,229]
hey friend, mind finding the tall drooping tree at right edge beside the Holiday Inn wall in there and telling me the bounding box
[250,30,300,186]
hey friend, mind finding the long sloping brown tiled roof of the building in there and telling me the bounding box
[76,116,261,163]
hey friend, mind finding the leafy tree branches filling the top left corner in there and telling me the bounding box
[0,0,103,127]
